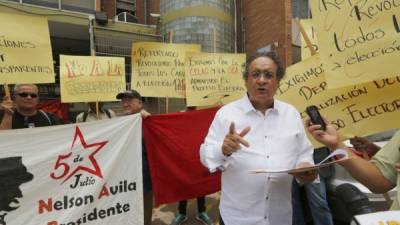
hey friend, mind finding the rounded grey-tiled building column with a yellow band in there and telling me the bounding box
[160,0,235,52]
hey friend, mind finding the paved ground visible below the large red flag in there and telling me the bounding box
[152,193,219,225]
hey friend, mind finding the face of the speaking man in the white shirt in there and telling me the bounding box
[246,57,279,109]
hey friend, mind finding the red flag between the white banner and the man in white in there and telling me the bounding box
[143,108,221,206]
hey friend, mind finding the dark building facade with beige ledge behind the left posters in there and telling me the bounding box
[0,0,162,116]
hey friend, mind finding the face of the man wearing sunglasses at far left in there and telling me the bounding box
[14,86,39,109]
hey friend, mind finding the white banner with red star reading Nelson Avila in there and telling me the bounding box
[0,115,143,225]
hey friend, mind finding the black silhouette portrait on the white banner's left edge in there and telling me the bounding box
[0,157,33,225]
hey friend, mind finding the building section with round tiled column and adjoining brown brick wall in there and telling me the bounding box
[156,0,294,65]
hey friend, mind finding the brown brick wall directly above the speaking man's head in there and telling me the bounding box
[236,0,295,65]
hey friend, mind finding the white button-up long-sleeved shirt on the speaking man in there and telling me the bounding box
[200,95,314,225]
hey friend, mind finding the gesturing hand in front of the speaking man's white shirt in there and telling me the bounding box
[222,122,250,156]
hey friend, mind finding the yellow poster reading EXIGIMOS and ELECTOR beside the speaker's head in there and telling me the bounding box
[276,54,400,146]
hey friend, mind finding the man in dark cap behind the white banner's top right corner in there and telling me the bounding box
[116,90,153,225]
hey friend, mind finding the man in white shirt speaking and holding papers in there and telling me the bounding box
[200,52,317,225]
